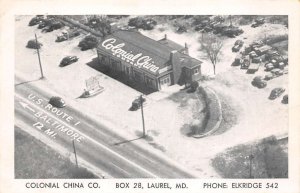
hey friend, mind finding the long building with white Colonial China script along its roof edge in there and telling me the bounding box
[97,30,202,90]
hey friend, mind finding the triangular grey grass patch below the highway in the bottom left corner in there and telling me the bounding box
[15,127,97,179]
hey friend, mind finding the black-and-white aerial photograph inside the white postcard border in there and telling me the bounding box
[14,14,289,179]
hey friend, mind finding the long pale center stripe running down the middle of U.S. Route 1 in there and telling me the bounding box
[15,93,158,178]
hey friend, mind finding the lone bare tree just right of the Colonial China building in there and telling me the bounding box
[200,34,223,74]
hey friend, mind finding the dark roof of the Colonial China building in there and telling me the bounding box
[98,30,201,75]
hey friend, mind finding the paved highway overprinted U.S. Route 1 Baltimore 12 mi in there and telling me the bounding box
[15,76,193,178]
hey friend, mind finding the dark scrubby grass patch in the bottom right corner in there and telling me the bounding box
[212,137,288,178]
